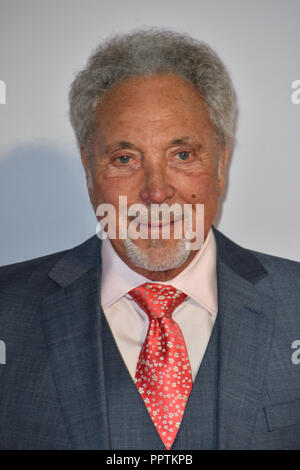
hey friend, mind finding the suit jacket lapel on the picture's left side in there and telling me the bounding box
[42,237,109,449]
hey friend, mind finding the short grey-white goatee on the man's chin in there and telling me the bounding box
[124,238,190,271]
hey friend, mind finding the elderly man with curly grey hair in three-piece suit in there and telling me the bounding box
[0,30,300,450]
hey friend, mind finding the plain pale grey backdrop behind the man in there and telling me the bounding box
[0,0,300,265]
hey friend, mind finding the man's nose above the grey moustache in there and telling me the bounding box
[140,165,176,204]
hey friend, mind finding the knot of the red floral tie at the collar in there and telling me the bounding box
[129,283,187,320]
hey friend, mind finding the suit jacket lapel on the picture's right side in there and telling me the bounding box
[214,229,276,449]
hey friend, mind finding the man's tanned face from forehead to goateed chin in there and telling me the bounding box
[82,74,228,281]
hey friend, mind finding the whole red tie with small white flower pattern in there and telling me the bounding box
[129,283,193,450]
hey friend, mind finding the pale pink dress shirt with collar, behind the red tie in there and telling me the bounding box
[101,229,218,380]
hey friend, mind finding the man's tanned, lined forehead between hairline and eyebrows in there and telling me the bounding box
[96,74,214,145]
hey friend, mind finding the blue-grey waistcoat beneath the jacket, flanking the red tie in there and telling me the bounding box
[102,315,219,450]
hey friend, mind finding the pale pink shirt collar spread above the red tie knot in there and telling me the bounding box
[101,229,218,315]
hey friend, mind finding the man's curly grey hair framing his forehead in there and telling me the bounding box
[69,28,238,155]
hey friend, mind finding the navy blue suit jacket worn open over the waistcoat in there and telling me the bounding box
[0,228,300,449]
